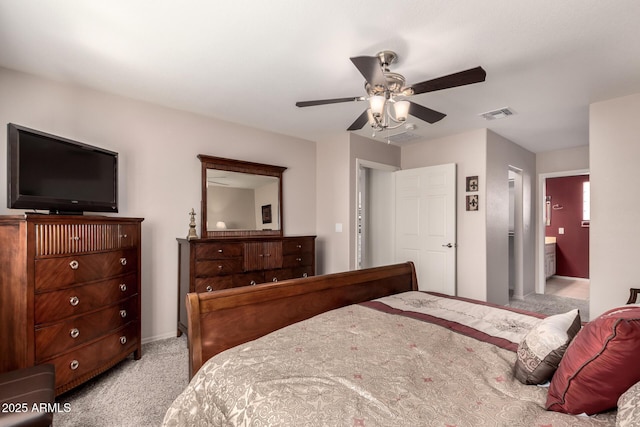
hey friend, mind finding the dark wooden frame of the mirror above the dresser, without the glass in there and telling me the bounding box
[198,154,287,238]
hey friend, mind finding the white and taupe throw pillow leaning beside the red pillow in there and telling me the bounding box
[513,310,581,384]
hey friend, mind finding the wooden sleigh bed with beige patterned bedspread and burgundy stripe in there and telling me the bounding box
[163,263,640,427]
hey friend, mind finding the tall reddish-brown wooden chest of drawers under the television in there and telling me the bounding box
[0,214,142,394]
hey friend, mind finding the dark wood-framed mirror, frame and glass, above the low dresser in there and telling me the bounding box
[198,154,286,238]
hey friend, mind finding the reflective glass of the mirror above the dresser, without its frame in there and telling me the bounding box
[207,169,280,231]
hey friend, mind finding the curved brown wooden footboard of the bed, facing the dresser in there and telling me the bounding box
[186,262,418,377]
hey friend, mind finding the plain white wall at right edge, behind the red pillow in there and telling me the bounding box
[589,94,640,319]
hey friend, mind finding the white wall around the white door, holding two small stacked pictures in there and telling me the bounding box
[401,129,488,301]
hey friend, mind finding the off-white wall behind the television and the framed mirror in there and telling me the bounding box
[0,68,316,341]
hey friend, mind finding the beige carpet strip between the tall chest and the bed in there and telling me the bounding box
[53,335,189,427]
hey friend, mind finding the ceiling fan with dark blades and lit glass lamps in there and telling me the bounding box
[296,50,487,131]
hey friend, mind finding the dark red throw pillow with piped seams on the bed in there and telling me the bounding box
[546,306,640,415]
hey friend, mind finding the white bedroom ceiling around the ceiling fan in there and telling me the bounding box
[0,0,640,152]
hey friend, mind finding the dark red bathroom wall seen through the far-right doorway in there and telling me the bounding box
[546,175,589,278]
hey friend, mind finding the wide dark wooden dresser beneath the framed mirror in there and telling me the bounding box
[178,236,316,335]
